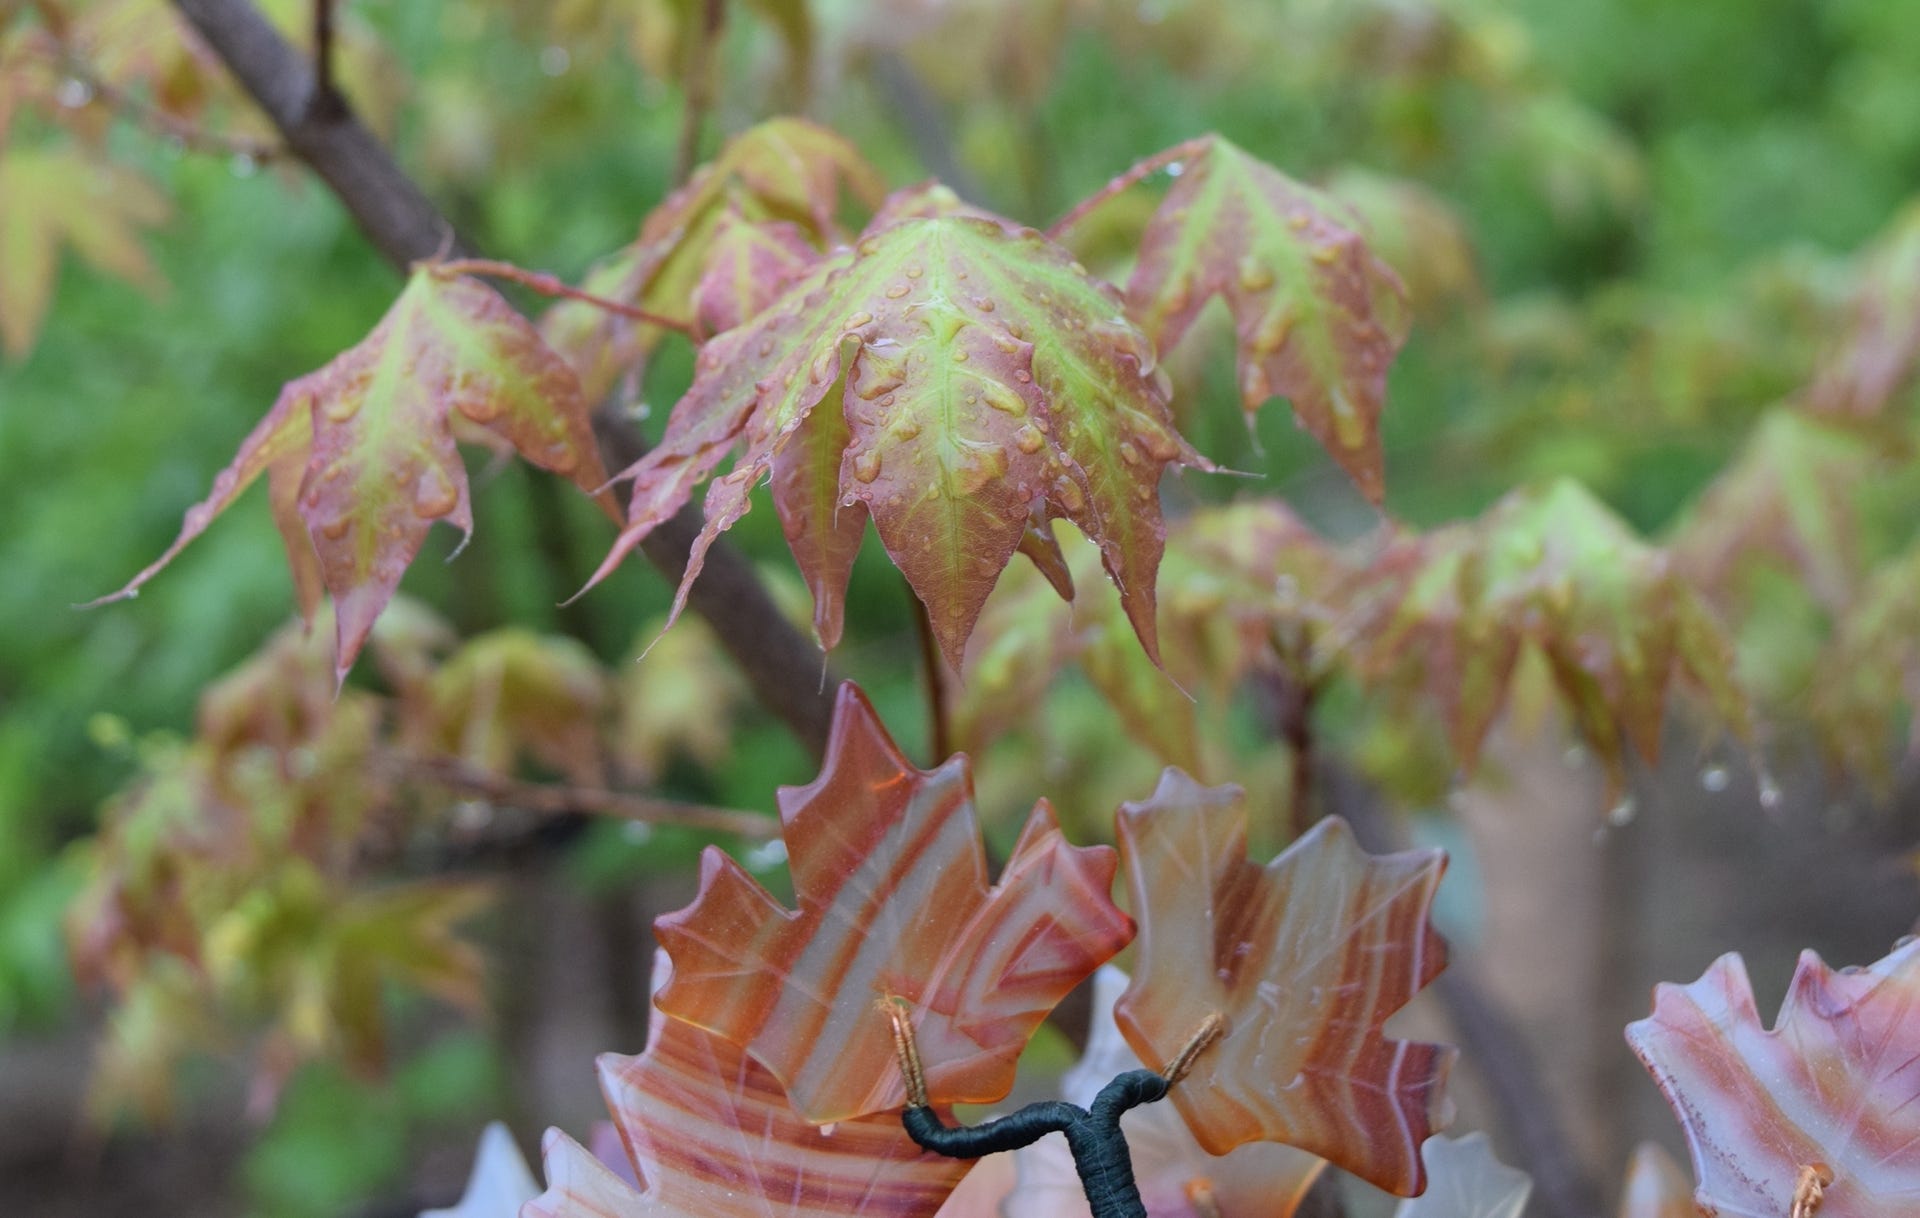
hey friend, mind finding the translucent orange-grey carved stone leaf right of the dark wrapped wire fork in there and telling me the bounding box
[1114,768,1453,1197]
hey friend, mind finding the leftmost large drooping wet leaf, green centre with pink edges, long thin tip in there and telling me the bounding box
[94,263,612,680]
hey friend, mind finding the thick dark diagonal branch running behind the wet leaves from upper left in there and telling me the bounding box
[157,0,833,757]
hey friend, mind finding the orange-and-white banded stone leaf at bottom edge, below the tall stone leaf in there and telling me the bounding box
[524,952,972,1218]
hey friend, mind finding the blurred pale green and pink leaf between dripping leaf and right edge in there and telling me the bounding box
[1672,409,1884,611]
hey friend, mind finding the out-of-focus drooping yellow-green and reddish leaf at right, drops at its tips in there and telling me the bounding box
[1332,480,1751,786]
